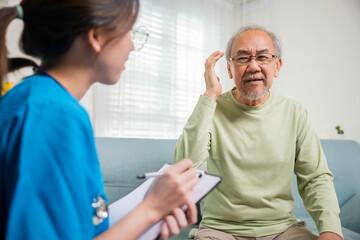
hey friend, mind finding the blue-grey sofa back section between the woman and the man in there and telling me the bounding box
[95,138,176,203]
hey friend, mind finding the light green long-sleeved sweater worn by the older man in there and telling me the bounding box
[175,91,342,237]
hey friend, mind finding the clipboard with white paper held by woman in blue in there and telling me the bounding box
[109,164,222,240]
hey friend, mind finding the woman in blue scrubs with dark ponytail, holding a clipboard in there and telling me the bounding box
[0,0,199,239]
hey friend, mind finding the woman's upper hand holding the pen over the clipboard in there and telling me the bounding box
[144,159,199,220]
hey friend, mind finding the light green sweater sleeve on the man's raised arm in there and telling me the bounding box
[174,95,216,167]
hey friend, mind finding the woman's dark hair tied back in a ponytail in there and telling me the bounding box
[0,0,139,95]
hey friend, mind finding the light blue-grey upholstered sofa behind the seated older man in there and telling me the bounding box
[96,137,360,240]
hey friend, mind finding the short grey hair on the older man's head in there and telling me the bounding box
[225,25,282,61]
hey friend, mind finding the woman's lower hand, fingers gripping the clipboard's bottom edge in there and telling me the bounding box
[159,199,197,240]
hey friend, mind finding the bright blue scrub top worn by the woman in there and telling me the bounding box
[0,75,109,240]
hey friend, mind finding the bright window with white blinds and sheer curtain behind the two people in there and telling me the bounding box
[93,0,240,139]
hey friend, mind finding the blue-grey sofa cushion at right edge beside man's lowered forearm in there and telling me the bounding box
[340,193,360,233]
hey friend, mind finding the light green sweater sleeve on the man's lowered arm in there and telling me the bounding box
[294,106,342,236]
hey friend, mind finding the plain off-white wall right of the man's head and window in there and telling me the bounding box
[222,0,360,142]
